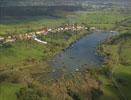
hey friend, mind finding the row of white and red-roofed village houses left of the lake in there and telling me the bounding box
[0,24,87,43]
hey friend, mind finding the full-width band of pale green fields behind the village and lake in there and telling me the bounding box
[0,11,130,35]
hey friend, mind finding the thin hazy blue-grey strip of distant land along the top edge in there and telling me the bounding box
[0,0,131,6]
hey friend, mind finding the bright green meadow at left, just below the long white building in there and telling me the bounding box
[0,41,47,65]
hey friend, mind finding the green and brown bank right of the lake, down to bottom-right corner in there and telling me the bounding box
[97,33,131,100]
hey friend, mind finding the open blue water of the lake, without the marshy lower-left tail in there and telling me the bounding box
[50,31,117,71]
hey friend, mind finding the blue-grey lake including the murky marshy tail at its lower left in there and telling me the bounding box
[34,31,118,82]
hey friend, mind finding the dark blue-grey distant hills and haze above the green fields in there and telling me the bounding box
[0,0,131,22]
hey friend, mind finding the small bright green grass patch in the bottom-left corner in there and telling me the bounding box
[0,83,22,100]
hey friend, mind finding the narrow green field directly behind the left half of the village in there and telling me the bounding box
[0,18,64,35]
